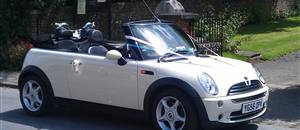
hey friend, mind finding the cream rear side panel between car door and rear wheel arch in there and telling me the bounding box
[29,48,73,98]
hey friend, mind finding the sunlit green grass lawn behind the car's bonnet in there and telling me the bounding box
[224,16,300,60]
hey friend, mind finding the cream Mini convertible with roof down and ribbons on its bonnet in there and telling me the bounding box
[19,20,269,130]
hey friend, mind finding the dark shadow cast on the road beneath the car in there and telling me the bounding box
[1,106,258,130]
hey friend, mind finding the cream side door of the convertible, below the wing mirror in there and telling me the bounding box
[69,54,138,109]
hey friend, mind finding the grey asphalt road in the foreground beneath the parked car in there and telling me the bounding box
[0,87,296,130]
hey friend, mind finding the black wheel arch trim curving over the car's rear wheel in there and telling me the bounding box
[18,65,54,96]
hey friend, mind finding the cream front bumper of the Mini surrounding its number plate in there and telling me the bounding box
[202,85,269,124]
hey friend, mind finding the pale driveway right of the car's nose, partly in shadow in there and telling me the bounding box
[253,51,300,130]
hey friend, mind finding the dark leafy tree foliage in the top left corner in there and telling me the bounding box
[0,0,67,46]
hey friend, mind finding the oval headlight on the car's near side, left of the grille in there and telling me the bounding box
[198,73,218,95]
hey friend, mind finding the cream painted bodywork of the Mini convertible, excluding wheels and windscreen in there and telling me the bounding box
[23,49,268,123]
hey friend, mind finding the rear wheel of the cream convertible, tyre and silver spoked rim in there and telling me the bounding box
[19,75,53,116]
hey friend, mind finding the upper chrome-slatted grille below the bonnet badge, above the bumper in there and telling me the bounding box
[228,80,262,96]
